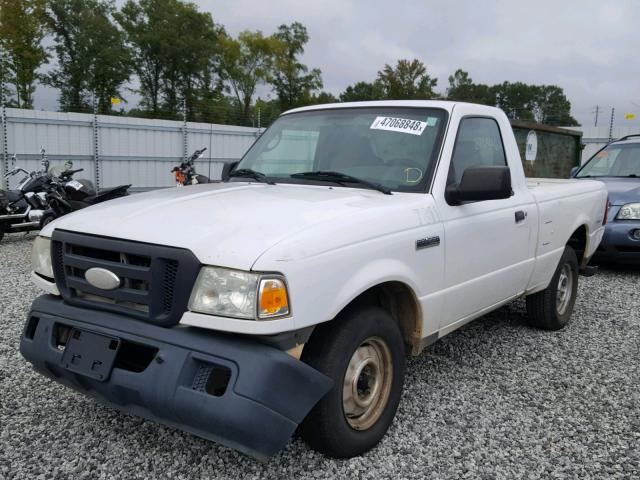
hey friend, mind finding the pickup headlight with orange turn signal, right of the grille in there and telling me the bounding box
[189,267,289,320]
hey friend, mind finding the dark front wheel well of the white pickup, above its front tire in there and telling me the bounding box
[347,282,422,355]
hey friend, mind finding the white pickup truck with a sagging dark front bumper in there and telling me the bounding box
[20,101,607,458]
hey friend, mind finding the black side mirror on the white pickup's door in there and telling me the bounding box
[446,166,513,205]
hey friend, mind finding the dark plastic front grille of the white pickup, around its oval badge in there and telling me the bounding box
[52,230,200,325]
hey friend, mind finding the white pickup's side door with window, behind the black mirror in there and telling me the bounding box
[434,110,537,333]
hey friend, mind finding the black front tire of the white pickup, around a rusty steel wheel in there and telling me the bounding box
[300,306,405,458]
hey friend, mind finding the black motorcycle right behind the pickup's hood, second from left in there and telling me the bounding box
[40,162,131,228]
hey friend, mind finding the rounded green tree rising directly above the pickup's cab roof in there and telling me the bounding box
[378,59,438,100]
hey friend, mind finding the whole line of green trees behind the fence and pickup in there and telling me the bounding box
[0,0,577,125]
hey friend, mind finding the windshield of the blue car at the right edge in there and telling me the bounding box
[576,143,640,177]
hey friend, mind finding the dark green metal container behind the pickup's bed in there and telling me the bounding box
[511,120,582,178]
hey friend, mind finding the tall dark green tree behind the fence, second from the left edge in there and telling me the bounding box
[46,0,131,113]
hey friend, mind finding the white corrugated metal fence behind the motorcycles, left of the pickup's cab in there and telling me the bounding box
[0,108,261,188]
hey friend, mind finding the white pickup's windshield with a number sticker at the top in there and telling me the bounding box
[234,107,447,192]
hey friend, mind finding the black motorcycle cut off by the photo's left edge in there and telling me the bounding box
[0,155,49,240]
